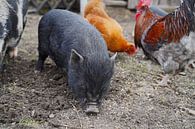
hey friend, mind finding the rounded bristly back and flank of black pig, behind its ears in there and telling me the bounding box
[39,9,109,68]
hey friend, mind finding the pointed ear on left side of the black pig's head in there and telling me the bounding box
[70,49,84,64]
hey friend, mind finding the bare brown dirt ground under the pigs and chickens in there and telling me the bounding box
[0,7,195,129]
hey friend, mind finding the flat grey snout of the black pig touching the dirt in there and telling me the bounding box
[85,102,100,114]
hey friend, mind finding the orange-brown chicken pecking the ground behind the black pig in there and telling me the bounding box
[84,0,136,55]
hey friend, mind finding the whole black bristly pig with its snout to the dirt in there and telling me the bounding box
[36,9,116,113]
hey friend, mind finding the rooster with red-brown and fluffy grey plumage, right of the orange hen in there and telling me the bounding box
[134,0,195,73]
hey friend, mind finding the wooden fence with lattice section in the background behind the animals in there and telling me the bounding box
[29,0,180,13]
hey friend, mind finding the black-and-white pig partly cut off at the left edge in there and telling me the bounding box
[0,0,28,71]
